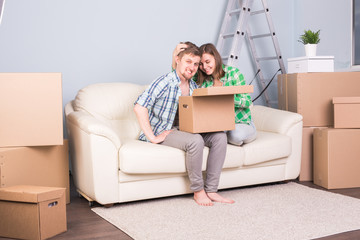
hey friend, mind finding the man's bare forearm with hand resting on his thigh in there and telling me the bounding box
[134,103,171,143]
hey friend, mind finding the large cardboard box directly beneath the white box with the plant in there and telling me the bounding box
[278,72,360,127]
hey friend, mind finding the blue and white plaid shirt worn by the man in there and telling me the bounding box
[135,71,198,141]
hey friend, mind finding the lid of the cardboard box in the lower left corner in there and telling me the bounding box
[0,185,65,203]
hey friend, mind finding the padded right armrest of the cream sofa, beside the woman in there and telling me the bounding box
[251,105,303,135]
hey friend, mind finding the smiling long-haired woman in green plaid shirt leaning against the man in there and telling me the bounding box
[173,43,256,146]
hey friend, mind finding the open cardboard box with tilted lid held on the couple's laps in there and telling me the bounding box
[179,85,254,133]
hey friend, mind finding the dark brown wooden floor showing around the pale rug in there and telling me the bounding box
[0,175,360,240]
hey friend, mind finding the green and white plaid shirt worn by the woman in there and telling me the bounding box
[201,65,252,124]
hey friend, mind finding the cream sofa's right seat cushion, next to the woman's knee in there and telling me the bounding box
[243,131,291,165]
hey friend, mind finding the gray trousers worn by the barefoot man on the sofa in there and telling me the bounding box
[160,129,227,192]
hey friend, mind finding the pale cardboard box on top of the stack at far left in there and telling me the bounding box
[0,73,63,147]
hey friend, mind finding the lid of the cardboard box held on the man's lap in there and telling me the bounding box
[192,85,254,97]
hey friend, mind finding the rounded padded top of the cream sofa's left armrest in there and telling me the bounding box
[66,111,121,149]
